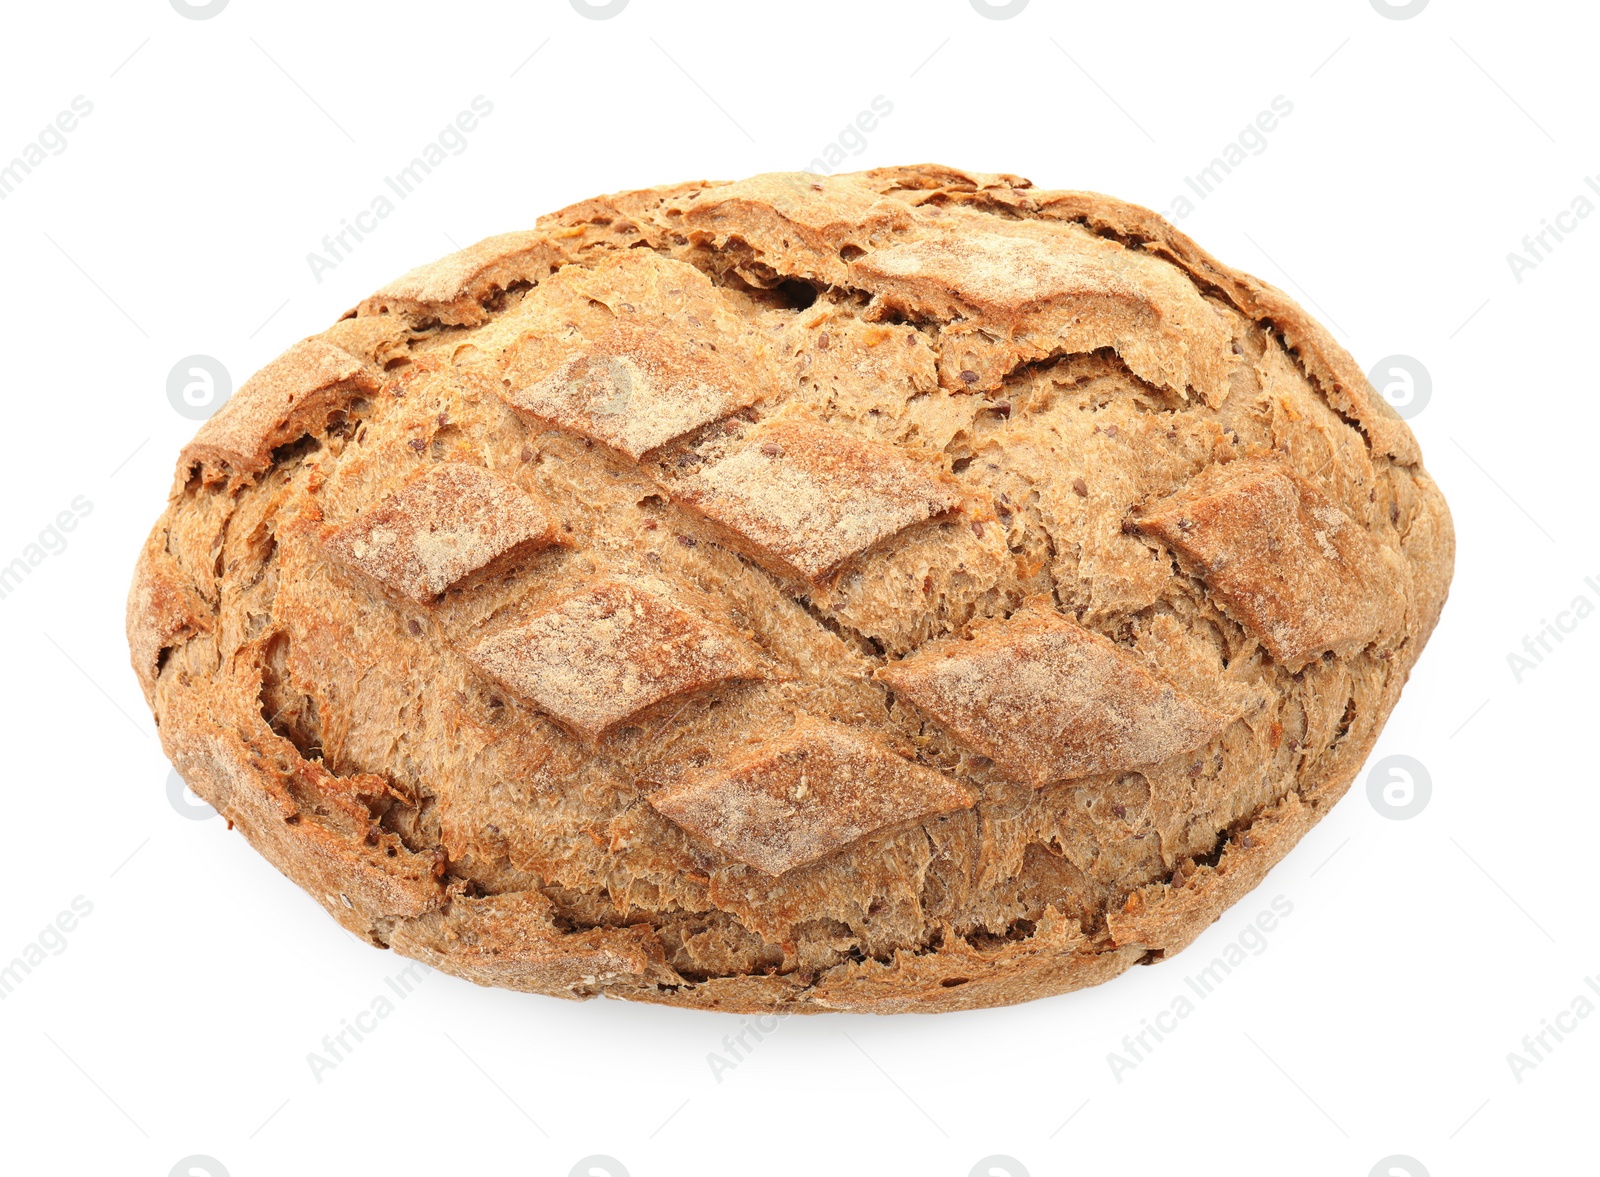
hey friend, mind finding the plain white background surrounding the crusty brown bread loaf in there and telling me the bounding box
[0,0,1600,1177]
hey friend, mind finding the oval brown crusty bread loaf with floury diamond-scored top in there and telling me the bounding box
[128,165,1453,1012]
